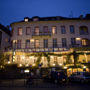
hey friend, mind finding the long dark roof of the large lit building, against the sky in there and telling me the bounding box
[11,14,90,25]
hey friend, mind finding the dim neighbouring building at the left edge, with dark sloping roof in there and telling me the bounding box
[0,24,11,51]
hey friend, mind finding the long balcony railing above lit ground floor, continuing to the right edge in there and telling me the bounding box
[8,43,90,52]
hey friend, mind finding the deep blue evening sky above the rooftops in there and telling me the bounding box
[0,0,90,26]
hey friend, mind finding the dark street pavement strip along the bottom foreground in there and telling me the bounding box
[0,79,90,90]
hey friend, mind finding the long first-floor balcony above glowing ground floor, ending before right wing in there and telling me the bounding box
[12,43,69,52]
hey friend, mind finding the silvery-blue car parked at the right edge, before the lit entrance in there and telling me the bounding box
[68,72,90,83]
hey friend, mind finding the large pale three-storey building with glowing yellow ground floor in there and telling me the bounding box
[10,14,90,67]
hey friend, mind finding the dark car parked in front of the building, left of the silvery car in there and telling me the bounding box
[44,71,67,83]
